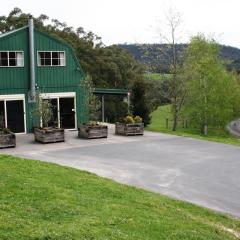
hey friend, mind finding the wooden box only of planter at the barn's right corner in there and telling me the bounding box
[78,125,108,139]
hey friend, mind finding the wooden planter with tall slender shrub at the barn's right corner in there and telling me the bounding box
[78,76,108,139]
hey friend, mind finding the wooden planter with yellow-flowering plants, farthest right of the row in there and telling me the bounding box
[115,116,144,136]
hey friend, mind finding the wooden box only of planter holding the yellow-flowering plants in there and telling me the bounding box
[115,123,144,136]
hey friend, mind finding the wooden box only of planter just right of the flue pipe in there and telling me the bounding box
[34,127,65,143]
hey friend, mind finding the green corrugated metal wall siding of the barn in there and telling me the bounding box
[0,28,88,132]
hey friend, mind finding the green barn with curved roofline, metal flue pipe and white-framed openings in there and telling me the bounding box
[0,17,87,133]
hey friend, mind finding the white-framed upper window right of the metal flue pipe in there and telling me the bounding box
[38,51,66,66]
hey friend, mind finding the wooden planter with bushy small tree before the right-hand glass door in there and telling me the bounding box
[33,93,65,143]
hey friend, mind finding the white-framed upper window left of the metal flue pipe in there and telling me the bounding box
[0,51,24,67]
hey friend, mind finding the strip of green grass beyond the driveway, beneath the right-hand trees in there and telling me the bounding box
[146,105,240,146]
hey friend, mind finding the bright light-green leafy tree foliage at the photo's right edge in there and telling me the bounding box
[184,35,240,132]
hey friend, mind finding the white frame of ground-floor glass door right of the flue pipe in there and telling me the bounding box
[40,92,77,131]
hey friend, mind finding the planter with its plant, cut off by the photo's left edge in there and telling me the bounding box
[0,114,16,148]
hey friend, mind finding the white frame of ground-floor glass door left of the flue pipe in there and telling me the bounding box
[0,94,27,134]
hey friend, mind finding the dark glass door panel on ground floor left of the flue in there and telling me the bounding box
[5,100,25,133]
